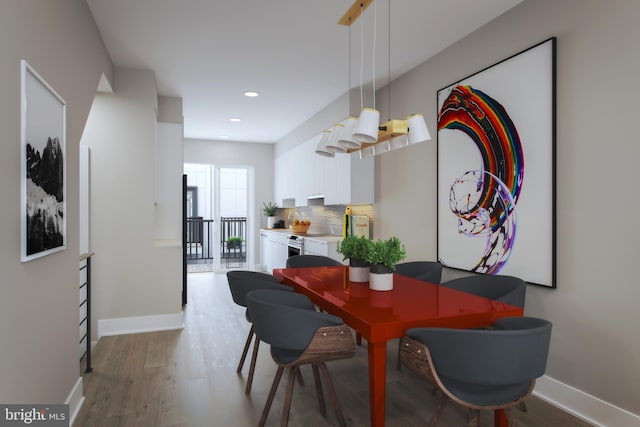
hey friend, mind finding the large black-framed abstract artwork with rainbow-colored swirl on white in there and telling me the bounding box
[438,37,556,288]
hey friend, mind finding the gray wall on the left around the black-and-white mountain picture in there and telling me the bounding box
[0,0,111,403]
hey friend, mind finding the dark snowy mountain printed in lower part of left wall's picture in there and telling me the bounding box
[26,137,64,255]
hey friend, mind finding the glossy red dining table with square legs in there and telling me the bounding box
[273,266,523,427]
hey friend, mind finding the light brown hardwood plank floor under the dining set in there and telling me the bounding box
[74,273,590,427]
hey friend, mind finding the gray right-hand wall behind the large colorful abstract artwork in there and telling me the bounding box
[278,0,640,420]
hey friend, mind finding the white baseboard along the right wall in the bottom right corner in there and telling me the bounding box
[533,375,640,427]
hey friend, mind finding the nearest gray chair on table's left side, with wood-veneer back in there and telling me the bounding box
[247,290,356,426]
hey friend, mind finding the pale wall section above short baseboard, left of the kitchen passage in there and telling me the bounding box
[83,68,182,338]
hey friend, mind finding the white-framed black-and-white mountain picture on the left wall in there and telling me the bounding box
[21,60,67,262]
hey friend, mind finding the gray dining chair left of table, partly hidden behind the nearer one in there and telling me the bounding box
[227,270,293,393]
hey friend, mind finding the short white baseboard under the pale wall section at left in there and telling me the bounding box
[98,312,184,339]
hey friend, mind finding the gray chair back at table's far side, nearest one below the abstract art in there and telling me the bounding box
[442,274,527,307]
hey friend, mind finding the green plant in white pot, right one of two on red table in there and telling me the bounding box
[367,236,407,291]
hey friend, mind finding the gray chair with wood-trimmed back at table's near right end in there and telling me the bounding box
[400,317,551,427]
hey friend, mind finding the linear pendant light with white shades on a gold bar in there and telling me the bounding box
[316,0,431,158]
